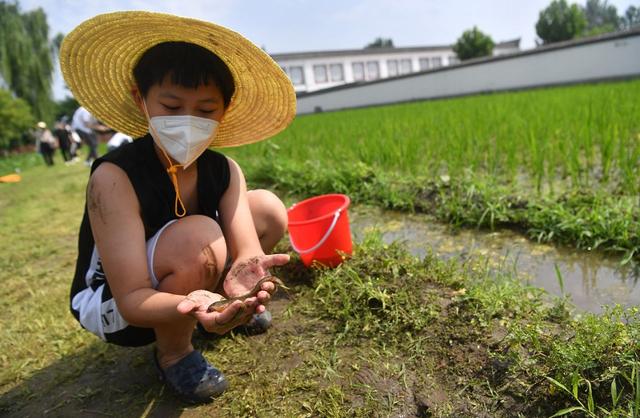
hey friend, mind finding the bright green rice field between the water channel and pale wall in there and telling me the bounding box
[228,80,640,260]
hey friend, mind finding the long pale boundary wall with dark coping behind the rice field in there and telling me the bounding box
[298,29,640,114]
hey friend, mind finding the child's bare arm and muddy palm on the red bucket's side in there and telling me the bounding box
[220,157,289,298]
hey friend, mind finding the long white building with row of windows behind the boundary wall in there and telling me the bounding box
[271,39,520,93]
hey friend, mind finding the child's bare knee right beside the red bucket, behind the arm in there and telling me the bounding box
[247,189,287,254]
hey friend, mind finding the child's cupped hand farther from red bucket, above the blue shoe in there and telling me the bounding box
[178,290,264,335]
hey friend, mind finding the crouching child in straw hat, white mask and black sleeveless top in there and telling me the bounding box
[60,12,295,402]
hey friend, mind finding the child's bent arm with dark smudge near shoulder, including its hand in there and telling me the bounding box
[87,162,250,332]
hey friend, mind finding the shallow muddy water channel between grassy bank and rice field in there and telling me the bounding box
[349,207,640,312]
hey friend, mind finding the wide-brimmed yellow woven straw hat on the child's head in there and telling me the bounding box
[60,11,296,147]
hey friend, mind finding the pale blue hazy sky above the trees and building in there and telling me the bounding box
[19,0,640,99]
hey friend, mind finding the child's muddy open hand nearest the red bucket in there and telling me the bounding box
[222,254,289,306]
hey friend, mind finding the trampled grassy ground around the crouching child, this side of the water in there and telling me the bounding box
[0,152,640,417]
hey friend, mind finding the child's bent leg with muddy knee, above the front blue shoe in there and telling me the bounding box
[153,215,227,368]
